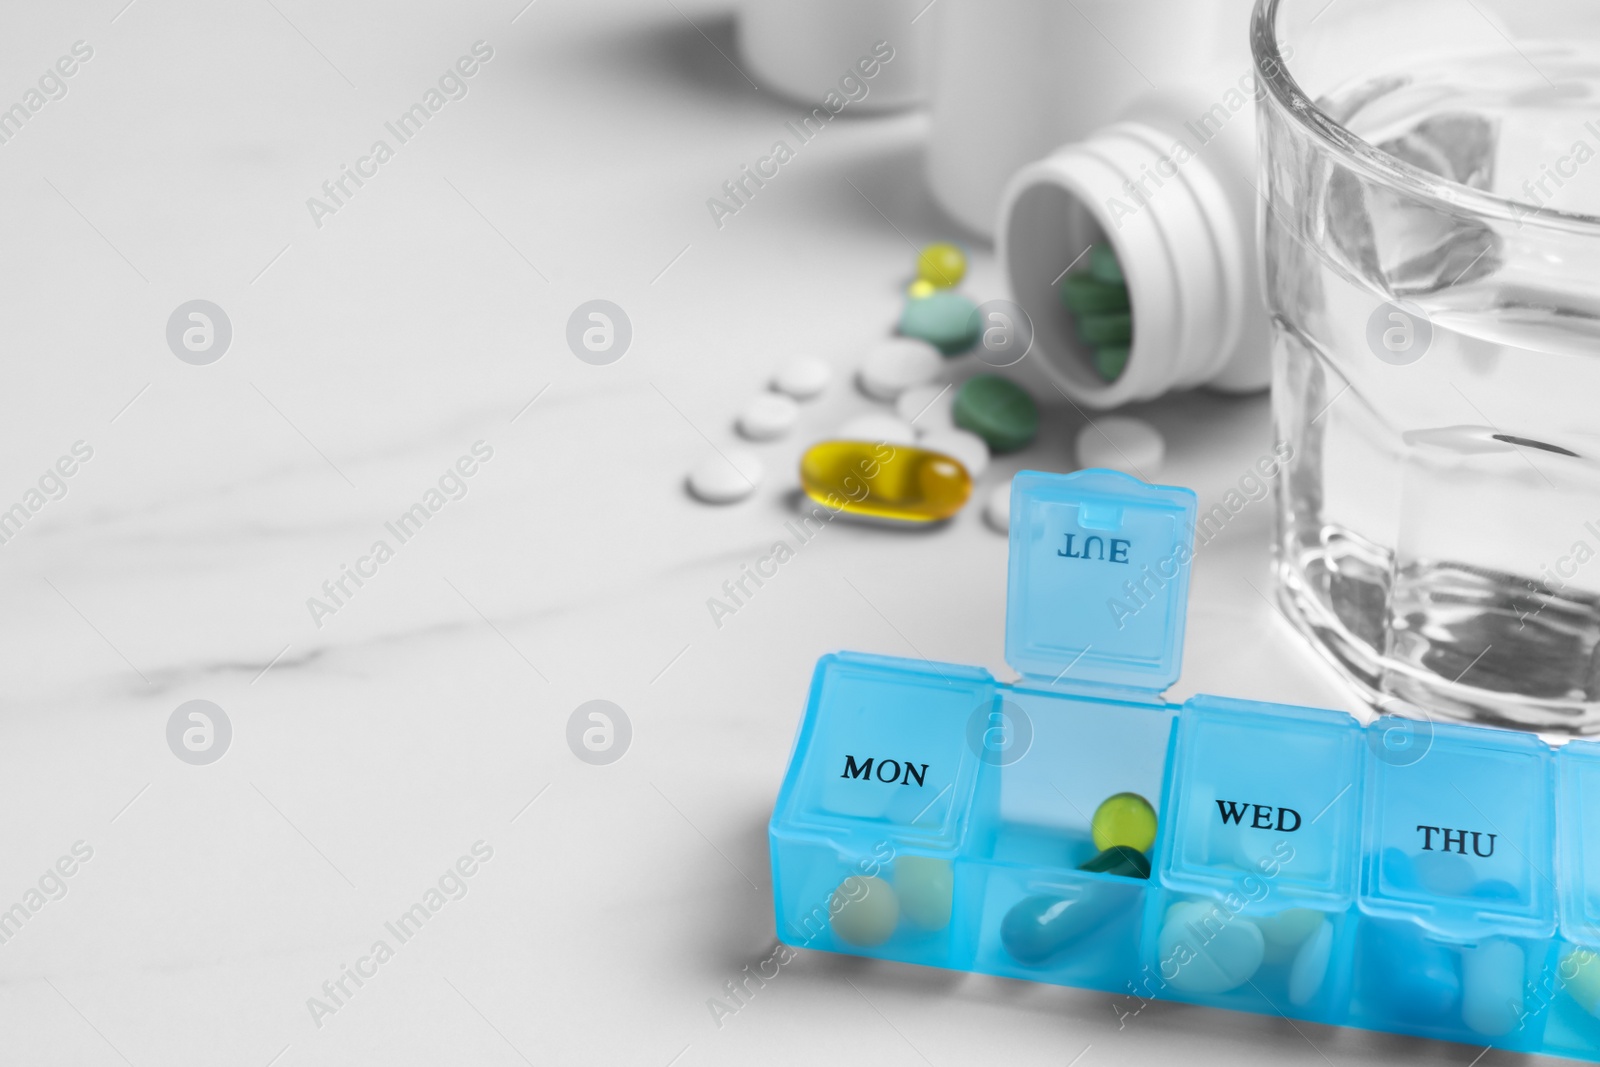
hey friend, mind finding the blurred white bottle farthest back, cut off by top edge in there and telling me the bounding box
[739,0,933,114]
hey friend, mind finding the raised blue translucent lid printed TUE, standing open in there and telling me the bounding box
[1005,470,1195,693]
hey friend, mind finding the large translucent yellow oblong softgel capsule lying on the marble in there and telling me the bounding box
[800,442,973,523]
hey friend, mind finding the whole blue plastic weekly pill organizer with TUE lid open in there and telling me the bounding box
[770,470,1600,1059]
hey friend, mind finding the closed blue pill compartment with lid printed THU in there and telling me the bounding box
[1350,718,1557,1049]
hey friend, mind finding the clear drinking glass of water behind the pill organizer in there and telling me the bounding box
[1251,0,1600,733]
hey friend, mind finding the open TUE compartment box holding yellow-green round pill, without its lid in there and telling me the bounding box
[963,688,1173,993]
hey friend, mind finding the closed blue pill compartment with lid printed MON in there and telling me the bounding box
[770,654,997,969]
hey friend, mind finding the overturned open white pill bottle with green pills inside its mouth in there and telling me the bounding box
[997,82,1272,408]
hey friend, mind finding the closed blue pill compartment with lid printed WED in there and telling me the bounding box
[1141,696,1365,1022]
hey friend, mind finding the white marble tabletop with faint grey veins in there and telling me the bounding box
[0,0,1474,1067]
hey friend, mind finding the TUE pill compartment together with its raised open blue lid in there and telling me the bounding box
[971,470,1195,993]
